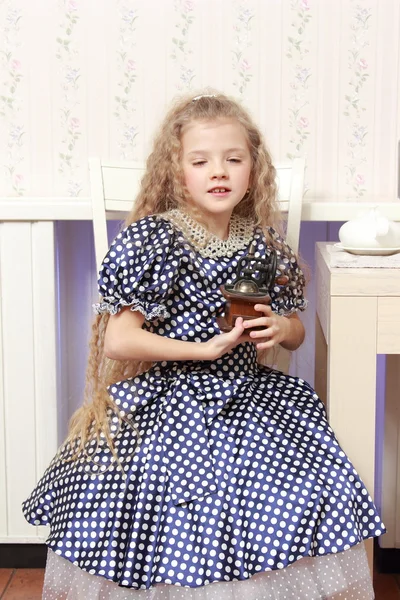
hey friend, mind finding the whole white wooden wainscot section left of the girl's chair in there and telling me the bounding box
[0,223,57,542]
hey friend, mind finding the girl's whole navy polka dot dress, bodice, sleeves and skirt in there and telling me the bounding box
[23,211,384,600]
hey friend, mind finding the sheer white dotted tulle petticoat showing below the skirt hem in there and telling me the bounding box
[43,544,374,600]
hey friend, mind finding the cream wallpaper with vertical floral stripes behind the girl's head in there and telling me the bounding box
[0,0,400,201]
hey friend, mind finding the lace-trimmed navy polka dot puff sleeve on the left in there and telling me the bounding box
[93,216,178,321]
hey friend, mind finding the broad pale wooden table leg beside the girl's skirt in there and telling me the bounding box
[327,296,377,569]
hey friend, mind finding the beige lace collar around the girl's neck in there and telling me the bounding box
[159,209,254,258]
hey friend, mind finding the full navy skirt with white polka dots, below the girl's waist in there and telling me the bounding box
[24,364,385,600]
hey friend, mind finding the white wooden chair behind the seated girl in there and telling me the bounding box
[89,158,305,372]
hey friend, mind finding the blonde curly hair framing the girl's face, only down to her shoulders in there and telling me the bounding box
[126,94,280,228]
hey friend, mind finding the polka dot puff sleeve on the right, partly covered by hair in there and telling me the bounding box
[269,228,307,316]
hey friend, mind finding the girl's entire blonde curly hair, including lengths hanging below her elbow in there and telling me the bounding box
[65,93,281,463]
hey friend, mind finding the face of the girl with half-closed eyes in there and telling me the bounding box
[181,119,252,222]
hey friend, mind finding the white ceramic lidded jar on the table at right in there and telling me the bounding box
[339,208,400,249]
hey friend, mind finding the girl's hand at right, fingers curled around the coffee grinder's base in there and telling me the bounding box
[243,304,290,350]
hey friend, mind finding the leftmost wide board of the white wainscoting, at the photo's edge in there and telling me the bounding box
[0,223,36,537]
